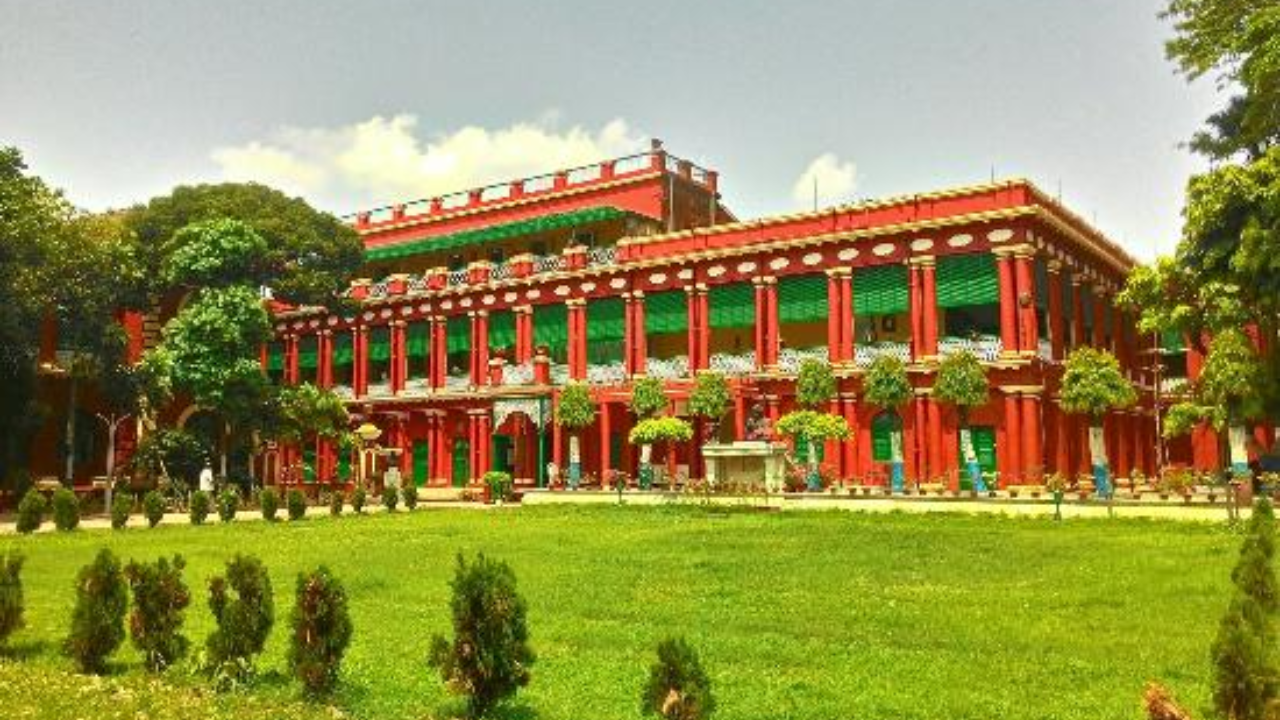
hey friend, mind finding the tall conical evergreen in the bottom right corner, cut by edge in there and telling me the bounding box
[1211,498,1280,720]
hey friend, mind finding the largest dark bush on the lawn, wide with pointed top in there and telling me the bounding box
[428,553,535,717]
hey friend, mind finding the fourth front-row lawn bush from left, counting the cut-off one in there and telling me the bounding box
[205,555,275,680]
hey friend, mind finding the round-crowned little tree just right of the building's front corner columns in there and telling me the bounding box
[1061,346,1138,497]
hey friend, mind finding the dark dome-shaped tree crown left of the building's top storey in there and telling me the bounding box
[128,183,364,306]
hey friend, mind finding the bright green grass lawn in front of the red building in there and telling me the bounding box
[0,507,1239,720]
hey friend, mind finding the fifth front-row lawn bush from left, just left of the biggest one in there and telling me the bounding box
[289,565,351,696]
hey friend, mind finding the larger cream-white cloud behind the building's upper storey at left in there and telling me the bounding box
[212,114,645,211]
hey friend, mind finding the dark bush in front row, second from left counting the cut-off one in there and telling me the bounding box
[64,548,129,673]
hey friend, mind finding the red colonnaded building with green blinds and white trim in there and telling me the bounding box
[264,143,1198,486]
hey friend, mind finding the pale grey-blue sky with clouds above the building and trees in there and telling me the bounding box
[0,0,1222,259]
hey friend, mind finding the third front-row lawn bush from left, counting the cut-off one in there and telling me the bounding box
[124,550,198,673]
